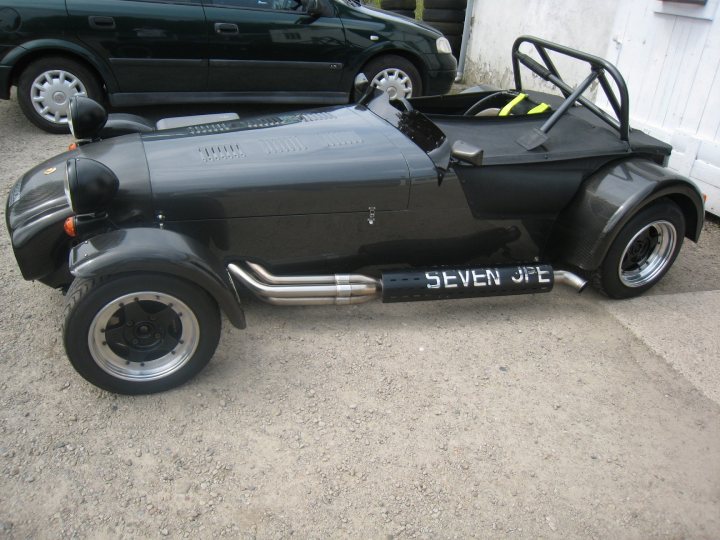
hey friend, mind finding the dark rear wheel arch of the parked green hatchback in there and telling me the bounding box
[0,39,117,93]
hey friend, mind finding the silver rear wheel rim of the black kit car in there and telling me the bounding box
[618,221,677,287]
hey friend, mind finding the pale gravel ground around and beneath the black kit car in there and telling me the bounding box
[0,95,720,539]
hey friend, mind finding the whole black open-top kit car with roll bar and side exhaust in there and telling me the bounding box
[7,37,704,393]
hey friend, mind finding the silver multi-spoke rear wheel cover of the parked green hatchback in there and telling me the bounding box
[30,69,87,124]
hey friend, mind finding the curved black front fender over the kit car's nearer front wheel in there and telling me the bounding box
[69,227,246,328]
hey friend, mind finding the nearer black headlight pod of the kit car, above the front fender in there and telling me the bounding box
[64,158,120,214]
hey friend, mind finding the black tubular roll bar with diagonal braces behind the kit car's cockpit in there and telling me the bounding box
[512,36,630,150]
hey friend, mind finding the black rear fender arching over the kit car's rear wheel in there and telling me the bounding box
[551,159,705,271]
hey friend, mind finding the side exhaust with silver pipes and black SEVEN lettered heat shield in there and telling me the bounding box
[228,262,587,306]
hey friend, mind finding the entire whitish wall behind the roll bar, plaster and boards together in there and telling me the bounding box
[464,0,720,215]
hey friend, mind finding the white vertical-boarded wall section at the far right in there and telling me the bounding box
[600,0,720,215]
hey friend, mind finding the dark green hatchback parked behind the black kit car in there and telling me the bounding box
[0,0,456,132]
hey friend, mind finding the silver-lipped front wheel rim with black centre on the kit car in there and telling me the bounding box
[88,291,200,381]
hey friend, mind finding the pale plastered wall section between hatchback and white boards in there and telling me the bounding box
[464,0,628,95]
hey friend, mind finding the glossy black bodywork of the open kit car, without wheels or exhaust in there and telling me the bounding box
[7,84,703,326]
